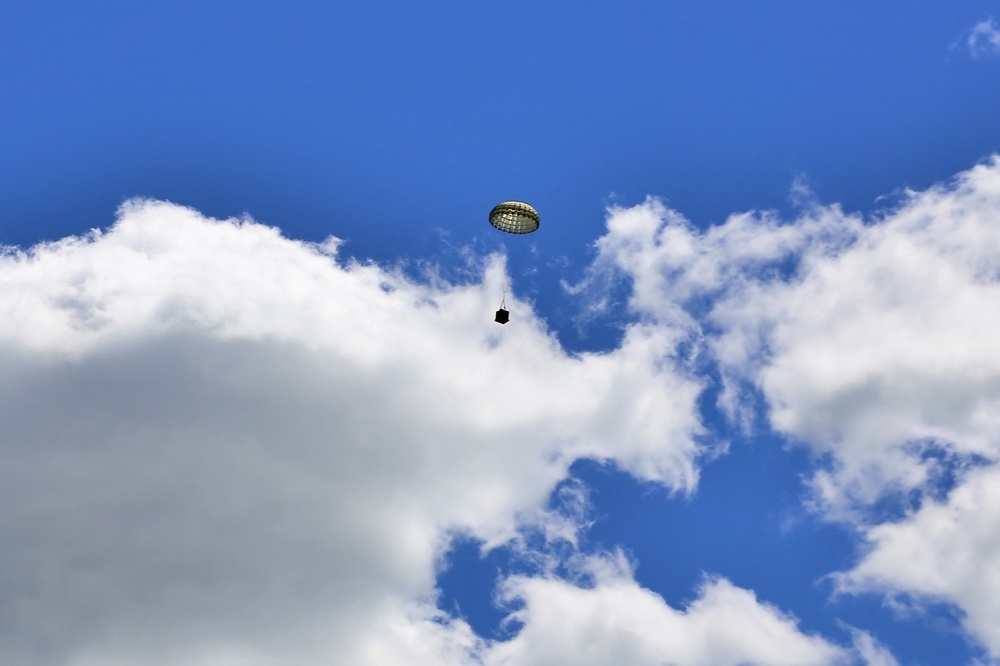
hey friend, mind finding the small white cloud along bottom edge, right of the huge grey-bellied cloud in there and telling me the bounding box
[485,554,849,666]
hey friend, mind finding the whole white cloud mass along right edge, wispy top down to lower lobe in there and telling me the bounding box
[589,157,1000,663]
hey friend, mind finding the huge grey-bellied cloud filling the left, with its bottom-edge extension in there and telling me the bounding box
[0,201,837,666]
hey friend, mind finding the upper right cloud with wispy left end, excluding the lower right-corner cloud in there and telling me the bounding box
[594,160,1000,507]
